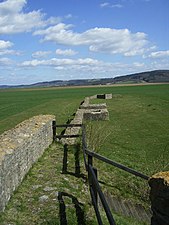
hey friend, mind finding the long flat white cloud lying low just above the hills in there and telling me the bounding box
[20,58,150,77]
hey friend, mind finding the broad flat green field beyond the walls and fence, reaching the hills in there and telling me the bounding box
[0,84,169,223]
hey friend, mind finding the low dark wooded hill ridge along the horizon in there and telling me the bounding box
[0,70,169,88]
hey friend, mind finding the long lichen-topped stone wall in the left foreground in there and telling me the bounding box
[0,115,55,211]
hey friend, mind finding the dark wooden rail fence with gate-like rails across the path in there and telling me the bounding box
[53,121,149,225]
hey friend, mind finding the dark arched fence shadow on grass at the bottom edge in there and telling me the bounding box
[58,192,86,225]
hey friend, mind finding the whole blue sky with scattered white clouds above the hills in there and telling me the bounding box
[0,0,169,85]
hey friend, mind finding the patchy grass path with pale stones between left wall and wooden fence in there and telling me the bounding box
[0,144,148,225]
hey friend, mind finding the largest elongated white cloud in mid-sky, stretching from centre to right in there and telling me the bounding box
[34,23,149,56]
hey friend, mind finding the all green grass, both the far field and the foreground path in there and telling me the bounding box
[0,84,169,225]
